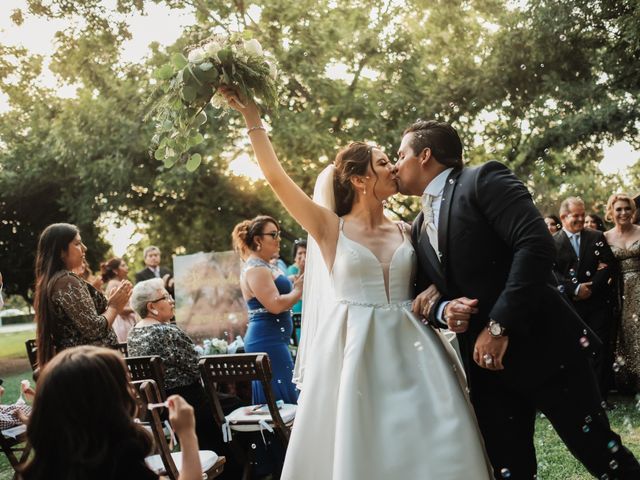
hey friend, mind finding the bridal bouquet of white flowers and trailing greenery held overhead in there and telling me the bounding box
[150,35,278,171]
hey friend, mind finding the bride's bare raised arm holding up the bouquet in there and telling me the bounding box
[220,88,339,250]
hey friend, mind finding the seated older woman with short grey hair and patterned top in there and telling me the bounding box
[127,278,222,452]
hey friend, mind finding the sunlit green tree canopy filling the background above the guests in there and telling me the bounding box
[0,0,640,296]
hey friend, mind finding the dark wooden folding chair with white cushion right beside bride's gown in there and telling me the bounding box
[198,353,297,479]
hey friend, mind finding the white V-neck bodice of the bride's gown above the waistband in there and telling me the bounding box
[331,223,416,305]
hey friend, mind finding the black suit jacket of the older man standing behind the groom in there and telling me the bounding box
[553,228,616,309]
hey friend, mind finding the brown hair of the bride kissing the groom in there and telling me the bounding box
[333,142,378,217]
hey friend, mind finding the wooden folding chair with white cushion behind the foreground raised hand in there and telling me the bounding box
[134,380,226,480]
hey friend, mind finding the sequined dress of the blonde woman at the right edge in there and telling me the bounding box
[611,240,640,393]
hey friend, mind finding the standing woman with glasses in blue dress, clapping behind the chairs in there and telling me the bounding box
[231,215,302,404]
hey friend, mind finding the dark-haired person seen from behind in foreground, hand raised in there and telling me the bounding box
[21,346,202,480]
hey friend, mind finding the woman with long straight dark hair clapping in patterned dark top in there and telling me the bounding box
[34,223,132,367]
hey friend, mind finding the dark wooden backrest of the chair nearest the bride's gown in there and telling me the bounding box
[198,353,290,448]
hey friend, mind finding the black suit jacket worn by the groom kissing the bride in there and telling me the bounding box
[412,162,597,391]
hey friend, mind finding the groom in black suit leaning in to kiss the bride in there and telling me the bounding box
[395,121,640,480]
